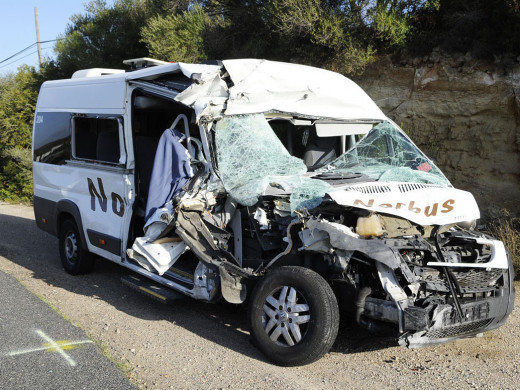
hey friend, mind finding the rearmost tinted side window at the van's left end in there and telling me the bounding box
[33,112,71,165]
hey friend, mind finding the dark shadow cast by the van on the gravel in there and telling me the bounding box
[0,210,395,361]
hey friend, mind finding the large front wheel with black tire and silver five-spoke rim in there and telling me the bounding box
[249,267,339,366]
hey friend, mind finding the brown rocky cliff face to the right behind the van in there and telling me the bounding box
[355,52,520,221]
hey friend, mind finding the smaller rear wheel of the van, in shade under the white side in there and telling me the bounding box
[59,219,94,275]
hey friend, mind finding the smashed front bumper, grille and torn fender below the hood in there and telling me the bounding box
[301,218,514,348]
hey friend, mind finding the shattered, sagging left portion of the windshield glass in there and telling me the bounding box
[215,114,332,212]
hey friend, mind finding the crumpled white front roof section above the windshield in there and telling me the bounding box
[223,59,386,120]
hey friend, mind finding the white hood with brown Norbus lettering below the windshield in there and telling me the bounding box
[328,182,480,225]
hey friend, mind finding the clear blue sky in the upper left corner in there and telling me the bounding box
[0,0,112,75]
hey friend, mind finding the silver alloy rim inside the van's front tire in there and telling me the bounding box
[262,286,311,347]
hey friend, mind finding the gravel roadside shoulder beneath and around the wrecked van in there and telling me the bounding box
[0,204,520,390]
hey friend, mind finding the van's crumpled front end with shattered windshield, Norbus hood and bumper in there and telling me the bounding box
[209,110,514,354]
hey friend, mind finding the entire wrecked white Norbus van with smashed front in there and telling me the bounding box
[33,59,514,365]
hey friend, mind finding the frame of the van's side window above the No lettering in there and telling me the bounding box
[70,113,128,168]
